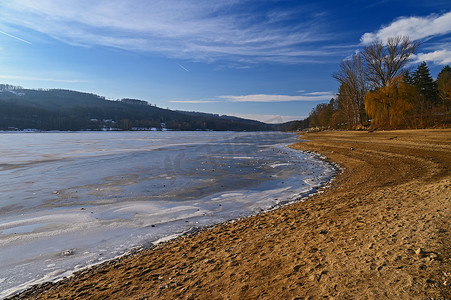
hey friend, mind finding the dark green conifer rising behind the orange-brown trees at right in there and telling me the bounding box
[412,62,439,105]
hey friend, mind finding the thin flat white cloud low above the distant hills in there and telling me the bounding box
[218,92,335,103]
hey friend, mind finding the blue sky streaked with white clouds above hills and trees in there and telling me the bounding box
[0,0,451,123]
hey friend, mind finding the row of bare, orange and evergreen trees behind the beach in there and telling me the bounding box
[306,36,451,129]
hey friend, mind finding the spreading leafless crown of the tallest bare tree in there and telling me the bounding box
[362,36,420,89]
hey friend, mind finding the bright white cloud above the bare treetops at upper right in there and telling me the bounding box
[361,11,451,45]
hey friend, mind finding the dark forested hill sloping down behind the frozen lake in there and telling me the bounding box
[0,84,286,131]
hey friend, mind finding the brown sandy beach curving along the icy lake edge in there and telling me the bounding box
[7,129,451,299]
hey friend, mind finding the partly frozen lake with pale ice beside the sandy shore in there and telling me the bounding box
[0,131,334,297]
